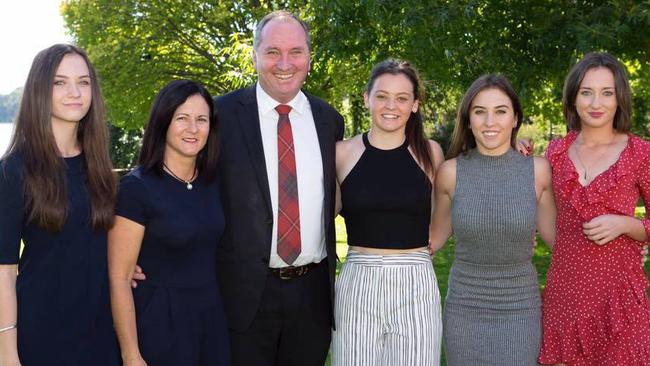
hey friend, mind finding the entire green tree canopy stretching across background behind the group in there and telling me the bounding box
[62,0,650,164]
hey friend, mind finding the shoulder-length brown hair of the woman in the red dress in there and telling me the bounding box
[562,52,632,133]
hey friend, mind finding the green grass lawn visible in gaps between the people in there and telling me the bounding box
[325,207,650,366]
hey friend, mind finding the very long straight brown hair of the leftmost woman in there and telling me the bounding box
[6,44,116,231]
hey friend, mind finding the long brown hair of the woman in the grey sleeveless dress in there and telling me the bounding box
[447,74,524,159]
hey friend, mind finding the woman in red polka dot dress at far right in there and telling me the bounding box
[539,53,650,366]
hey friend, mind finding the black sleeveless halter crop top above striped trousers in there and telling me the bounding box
[341,132,431,249]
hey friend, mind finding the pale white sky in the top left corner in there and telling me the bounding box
[0,0,71,94]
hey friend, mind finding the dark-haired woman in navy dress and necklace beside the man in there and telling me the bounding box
[108,80,230,366]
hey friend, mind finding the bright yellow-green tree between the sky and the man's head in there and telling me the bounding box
[62,0,265,129]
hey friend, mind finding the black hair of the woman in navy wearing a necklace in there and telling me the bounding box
[138,80,219,181]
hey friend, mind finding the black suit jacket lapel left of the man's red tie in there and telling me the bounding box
[237,84,273,215]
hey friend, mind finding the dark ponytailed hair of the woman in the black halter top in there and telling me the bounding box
[366,58,435,177]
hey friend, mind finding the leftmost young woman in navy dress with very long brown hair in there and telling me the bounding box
[0,44,119,366]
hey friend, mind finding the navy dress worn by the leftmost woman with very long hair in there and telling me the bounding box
[0,154,121,366]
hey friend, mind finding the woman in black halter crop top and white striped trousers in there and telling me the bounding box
[332,59,443,365]
